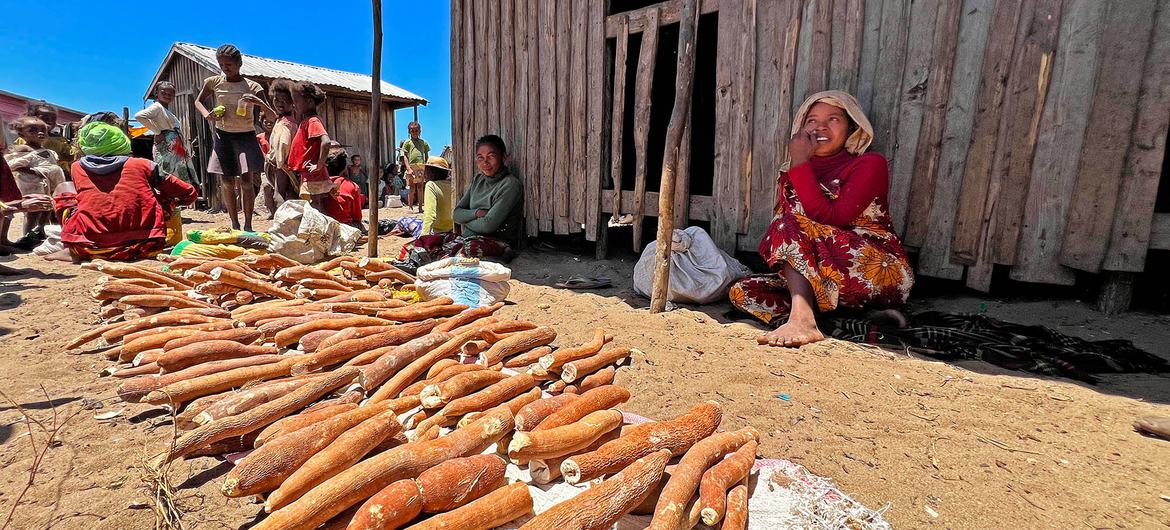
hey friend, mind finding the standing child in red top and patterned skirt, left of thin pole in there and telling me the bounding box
[289,83,333,211]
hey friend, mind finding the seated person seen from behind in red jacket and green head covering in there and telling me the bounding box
[44,122,198,261]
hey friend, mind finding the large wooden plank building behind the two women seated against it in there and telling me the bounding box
[452,0,1170,308]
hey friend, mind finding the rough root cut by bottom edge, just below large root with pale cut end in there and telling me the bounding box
[521,449,670,530]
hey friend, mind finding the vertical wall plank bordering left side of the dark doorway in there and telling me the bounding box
[585,1,608,241]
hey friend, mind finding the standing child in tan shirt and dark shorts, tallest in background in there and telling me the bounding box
[195,44,276,232]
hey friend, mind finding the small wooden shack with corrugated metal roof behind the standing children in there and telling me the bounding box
[143,42,427,207]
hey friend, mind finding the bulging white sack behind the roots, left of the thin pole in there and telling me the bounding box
[268,200,362,264]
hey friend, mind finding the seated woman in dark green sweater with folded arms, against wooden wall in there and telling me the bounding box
[400,135,524,266]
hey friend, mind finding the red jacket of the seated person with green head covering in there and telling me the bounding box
[61,158,199,248]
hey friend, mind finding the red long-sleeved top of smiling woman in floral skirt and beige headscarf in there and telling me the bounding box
[777,150,889,227]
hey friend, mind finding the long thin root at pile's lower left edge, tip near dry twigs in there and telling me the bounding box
[165,369,357,463]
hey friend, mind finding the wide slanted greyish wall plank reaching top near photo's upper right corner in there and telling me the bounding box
[1060,0,1157,273]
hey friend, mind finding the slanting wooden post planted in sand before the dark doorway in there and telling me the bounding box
[650,0,698,312]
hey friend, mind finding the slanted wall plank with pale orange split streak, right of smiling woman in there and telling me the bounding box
[983,0,1061,264]
